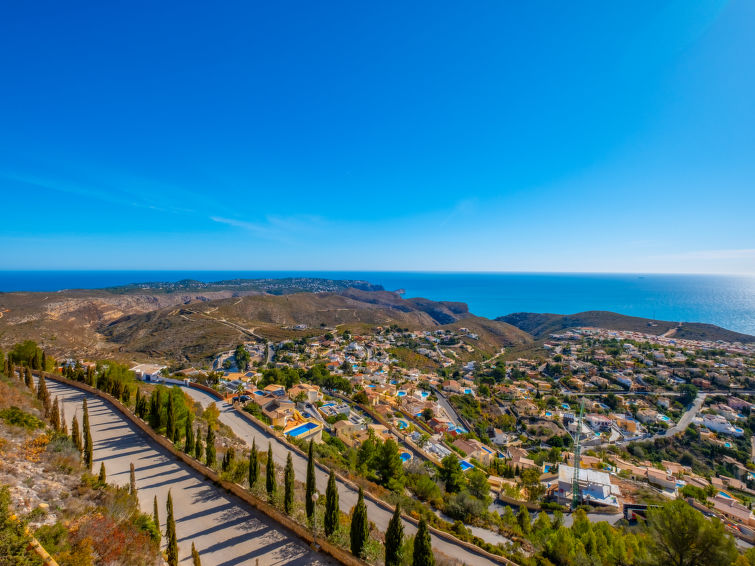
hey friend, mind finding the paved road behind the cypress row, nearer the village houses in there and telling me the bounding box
[183,387,499,566]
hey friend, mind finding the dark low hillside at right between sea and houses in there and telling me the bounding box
[495,311,755,343]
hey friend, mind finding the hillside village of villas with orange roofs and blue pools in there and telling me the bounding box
[115,327,755,552]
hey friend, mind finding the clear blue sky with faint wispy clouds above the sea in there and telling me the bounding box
[0,0,755,273]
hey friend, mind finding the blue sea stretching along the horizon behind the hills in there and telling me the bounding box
[0,271,755,335]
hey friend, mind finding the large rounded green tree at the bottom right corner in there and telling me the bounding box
[647,499,737,566]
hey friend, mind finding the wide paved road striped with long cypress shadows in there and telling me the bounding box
[42,380,337,566]
